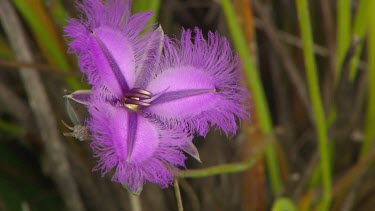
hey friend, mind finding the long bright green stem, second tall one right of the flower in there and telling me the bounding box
[296,0,331,210]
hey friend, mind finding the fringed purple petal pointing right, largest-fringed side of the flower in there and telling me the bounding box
[145,29,249,135]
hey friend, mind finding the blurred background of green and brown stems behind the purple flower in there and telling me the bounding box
[0,0,375,211]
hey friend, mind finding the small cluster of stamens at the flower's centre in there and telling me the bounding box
[124,88,152,112]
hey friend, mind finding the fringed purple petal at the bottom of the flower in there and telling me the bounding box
[87,100,189,193]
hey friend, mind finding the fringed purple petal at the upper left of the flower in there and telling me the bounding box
[65,0,161,98]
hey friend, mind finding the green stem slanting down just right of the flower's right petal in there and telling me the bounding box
[221,0,282,194]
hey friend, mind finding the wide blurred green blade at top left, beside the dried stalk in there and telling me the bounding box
[13,0,80,89]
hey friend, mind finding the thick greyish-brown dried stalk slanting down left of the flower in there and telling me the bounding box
[0,0,85,211]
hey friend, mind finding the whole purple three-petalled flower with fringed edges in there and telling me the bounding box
[65,0,248,193]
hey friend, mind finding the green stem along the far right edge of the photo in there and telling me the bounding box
[361,2,375,157]
